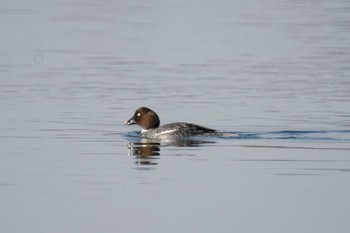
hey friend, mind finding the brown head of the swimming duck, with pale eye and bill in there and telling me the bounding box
[124,107,160,130]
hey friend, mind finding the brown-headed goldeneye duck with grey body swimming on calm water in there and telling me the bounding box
[124,107,219,140]
